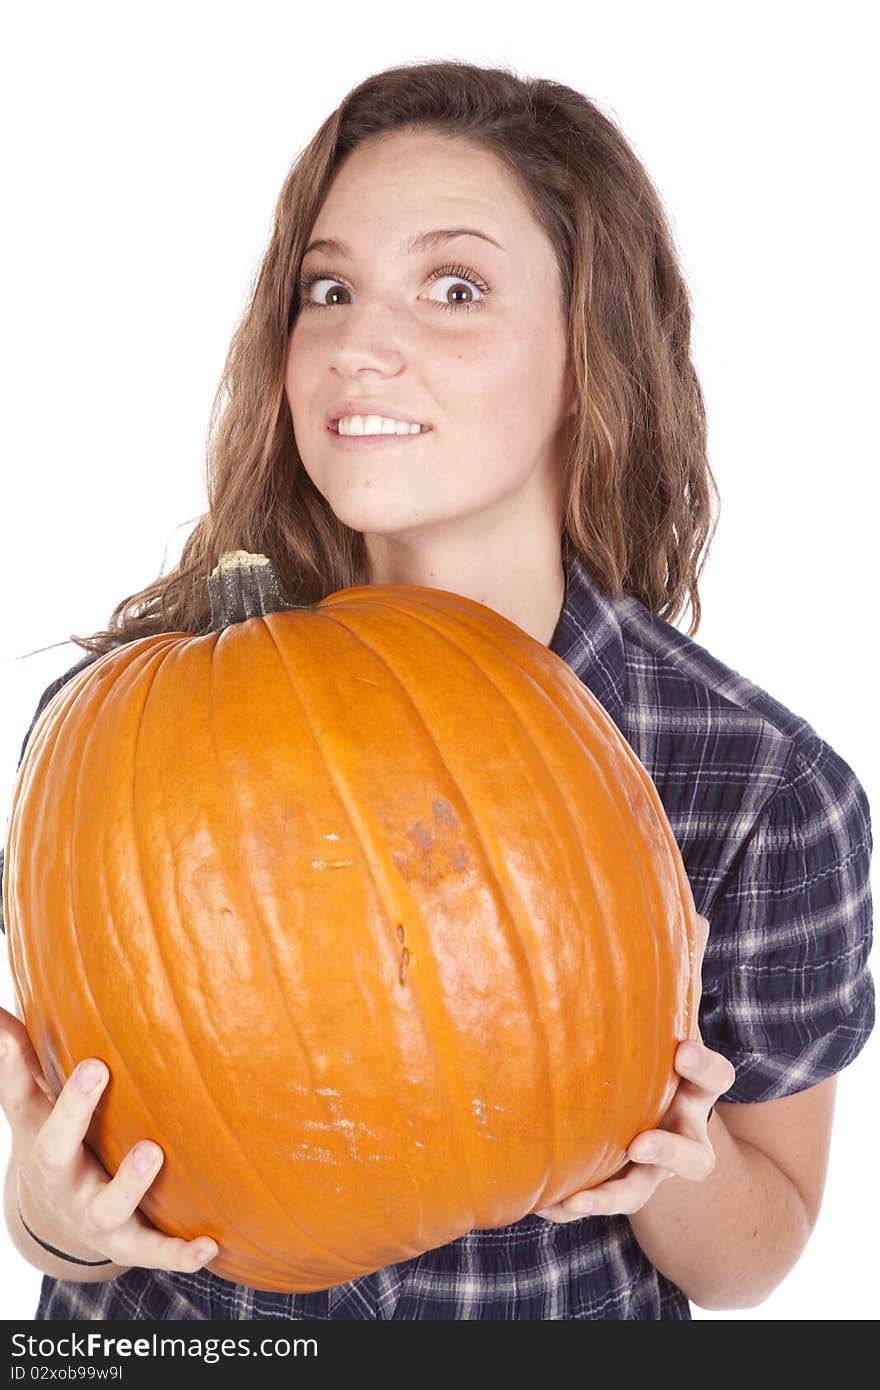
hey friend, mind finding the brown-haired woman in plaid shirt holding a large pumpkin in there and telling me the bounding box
[0,63,873,1319]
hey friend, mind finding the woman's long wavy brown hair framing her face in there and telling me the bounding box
[58,61,717,653]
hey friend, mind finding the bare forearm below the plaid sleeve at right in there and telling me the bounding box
[630,1112,810,1309]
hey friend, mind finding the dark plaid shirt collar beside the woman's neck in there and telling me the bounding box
[551,538,627,728]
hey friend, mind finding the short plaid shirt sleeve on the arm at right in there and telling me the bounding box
[701,734,874,1102]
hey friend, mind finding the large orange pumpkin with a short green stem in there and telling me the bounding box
[3,552,699,1291]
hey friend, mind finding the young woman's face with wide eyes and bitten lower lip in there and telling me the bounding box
[285,133,574,546]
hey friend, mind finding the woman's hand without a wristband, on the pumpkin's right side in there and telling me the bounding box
[535,915,737,1222]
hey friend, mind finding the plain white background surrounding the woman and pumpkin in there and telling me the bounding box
[0,0,880,1319]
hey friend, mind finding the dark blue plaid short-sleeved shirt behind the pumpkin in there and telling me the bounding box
[1,546,874,1319]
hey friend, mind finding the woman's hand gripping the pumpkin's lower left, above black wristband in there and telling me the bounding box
[0,1008,217,1273]
